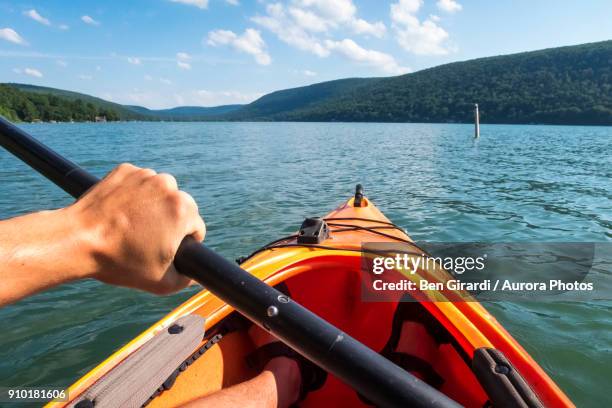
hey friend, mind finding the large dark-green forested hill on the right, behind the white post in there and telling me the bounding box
[225,41,612,125]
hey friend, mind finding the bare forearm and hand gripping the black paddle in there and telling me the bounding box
[0,164,206,306]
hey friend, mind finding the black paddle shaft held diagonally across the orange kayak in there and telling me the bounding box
[0,117,459,407]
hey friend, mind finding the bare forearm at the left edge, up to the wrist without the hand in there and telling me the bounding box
[0,207,96,306]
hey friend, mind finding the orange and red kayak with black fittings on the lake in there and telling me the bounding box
[47,189,574,408]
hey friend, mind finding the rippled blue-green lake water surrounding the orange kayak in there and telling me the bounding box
[0,123,612,406]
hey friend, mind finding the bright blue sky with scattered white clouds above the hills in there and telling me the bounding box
[0,0,612,108]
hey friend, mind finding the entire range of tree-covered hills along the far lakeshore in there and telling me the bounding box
[0,41,612,125]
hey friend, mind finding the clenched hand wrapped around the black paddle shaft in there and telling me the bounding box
[66,164,206,295]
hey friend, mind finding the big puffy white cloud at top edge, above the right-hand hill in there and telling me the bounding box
[391,0,451,55]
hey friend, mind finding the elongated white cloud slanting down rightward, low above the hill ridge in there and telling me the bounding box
[325,38,410,75]
